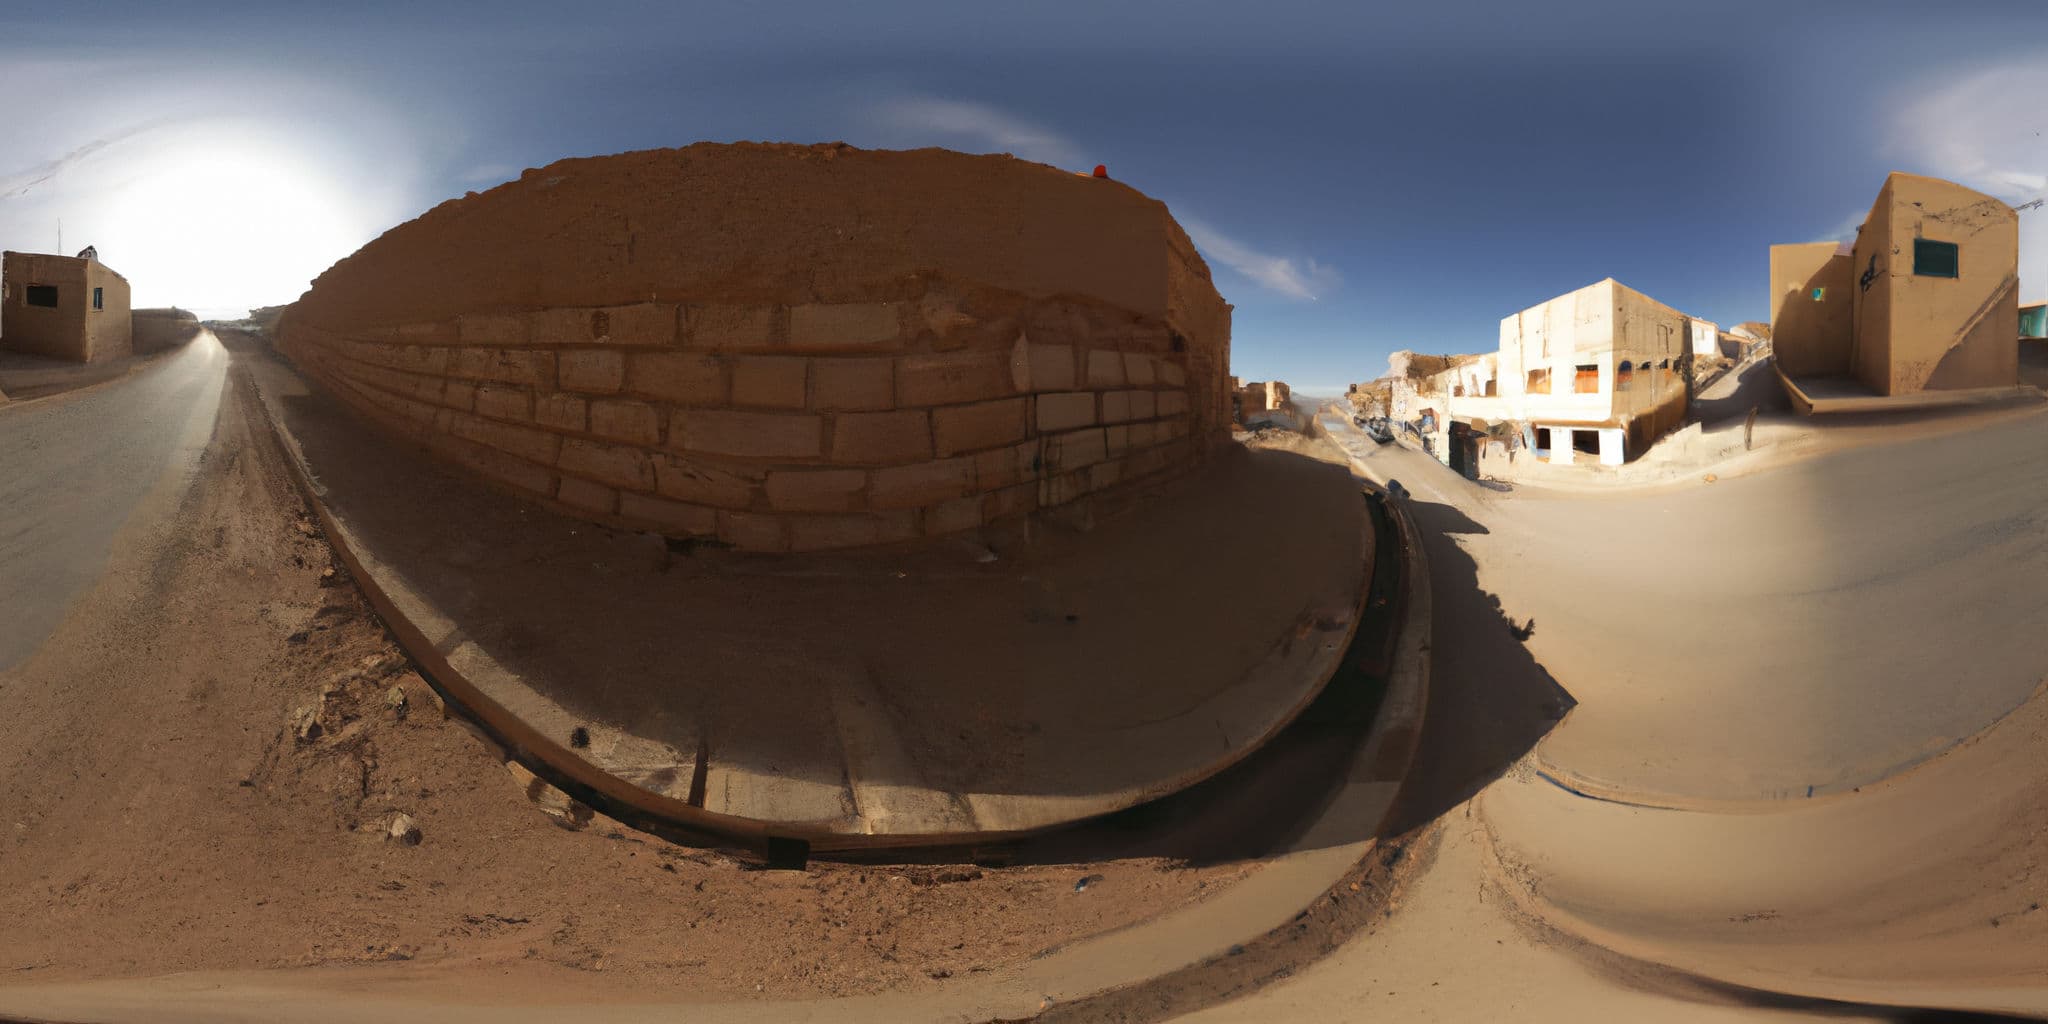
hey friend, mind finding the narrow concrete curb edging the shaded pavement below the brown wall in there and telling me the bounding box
[242,352,1378,852]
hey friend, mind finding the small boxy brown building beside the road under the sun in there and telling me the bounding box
[0,250,133,362]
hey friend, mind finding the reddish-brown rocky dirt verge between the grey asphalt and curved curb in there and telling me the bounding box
[0,342,1249,997]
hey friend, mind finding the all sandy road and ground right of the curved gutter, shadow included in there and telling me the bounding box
[1196,420,2048,1022]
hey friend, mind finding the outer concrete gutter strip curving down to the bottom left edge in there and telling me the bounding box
[0,399,1432,1024]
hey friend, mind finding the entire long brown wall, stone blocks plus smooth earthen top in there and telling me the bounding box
[279,145,1229,551]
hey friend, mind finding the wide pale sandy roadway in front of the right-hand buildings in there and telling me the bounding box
[1337,414,2048,805]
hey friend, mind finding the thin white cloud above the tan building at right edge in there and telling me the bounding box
[1890,57,2048,301]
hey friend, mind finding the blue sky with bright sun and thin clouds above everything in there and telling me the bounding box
[0,0,2048,391]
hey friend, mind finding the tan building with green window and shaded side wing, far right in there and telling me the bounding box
[1769,172,2019,408]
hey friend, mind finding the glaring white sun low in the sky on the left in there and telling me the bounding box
[91,141,381,315]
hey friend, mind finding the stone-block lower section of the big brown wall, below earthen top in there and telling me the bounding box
[285,288,1200,551]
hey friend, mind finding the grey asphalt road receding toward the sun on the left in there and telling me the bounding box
[0,334,227,672]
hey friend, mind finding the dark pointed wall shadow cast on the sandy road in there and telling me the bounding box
[1382,500,1577,836]
